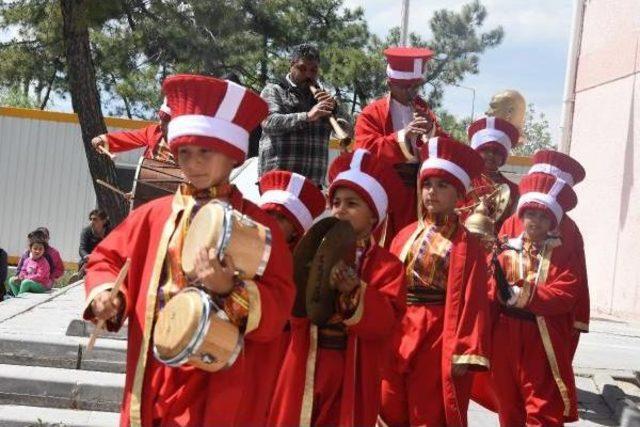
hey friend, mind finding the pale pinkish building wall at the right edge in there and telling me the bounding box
[570,0,640,319]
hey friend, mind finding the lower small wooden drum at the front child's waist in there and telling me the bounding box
[153,287,244,372]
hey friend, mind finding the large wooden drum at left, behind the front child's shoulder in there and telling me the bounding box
[131,157,186,209]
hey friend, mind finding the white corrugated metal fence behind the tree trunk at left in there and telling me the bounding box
[0,116,141,261]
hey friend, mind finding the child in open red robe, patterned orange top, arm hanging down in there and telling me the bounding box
[380,137,489,426]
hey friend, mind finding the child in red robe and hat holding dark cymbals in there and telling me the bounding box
[268,150,405,427]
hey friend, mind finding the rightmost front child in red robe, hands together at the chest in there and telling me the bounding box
[491,173,580,427]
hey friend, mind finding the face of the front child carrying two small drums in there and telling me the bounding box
[178,145,235,190]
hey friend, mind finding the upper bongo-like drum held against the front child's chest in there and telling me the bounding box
[182,200,271,279]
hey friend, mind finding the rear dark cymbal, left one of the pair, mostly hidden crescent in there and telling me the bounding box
[292,216,340,317]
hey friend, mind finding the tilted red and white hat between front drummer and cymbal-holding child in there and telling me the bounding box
[258,170,327,236]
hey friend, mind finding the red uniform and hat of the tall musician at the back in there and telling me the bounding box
[355,47,446,246]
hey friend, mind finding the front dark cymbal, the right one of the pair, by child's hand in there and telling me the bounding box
[305,221,357,326]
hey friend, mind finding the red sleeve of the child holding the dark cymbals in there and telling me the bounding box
[344,247,406,339]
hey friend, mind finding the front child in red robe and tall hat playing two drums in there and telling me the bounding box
[84,75,295,426]
